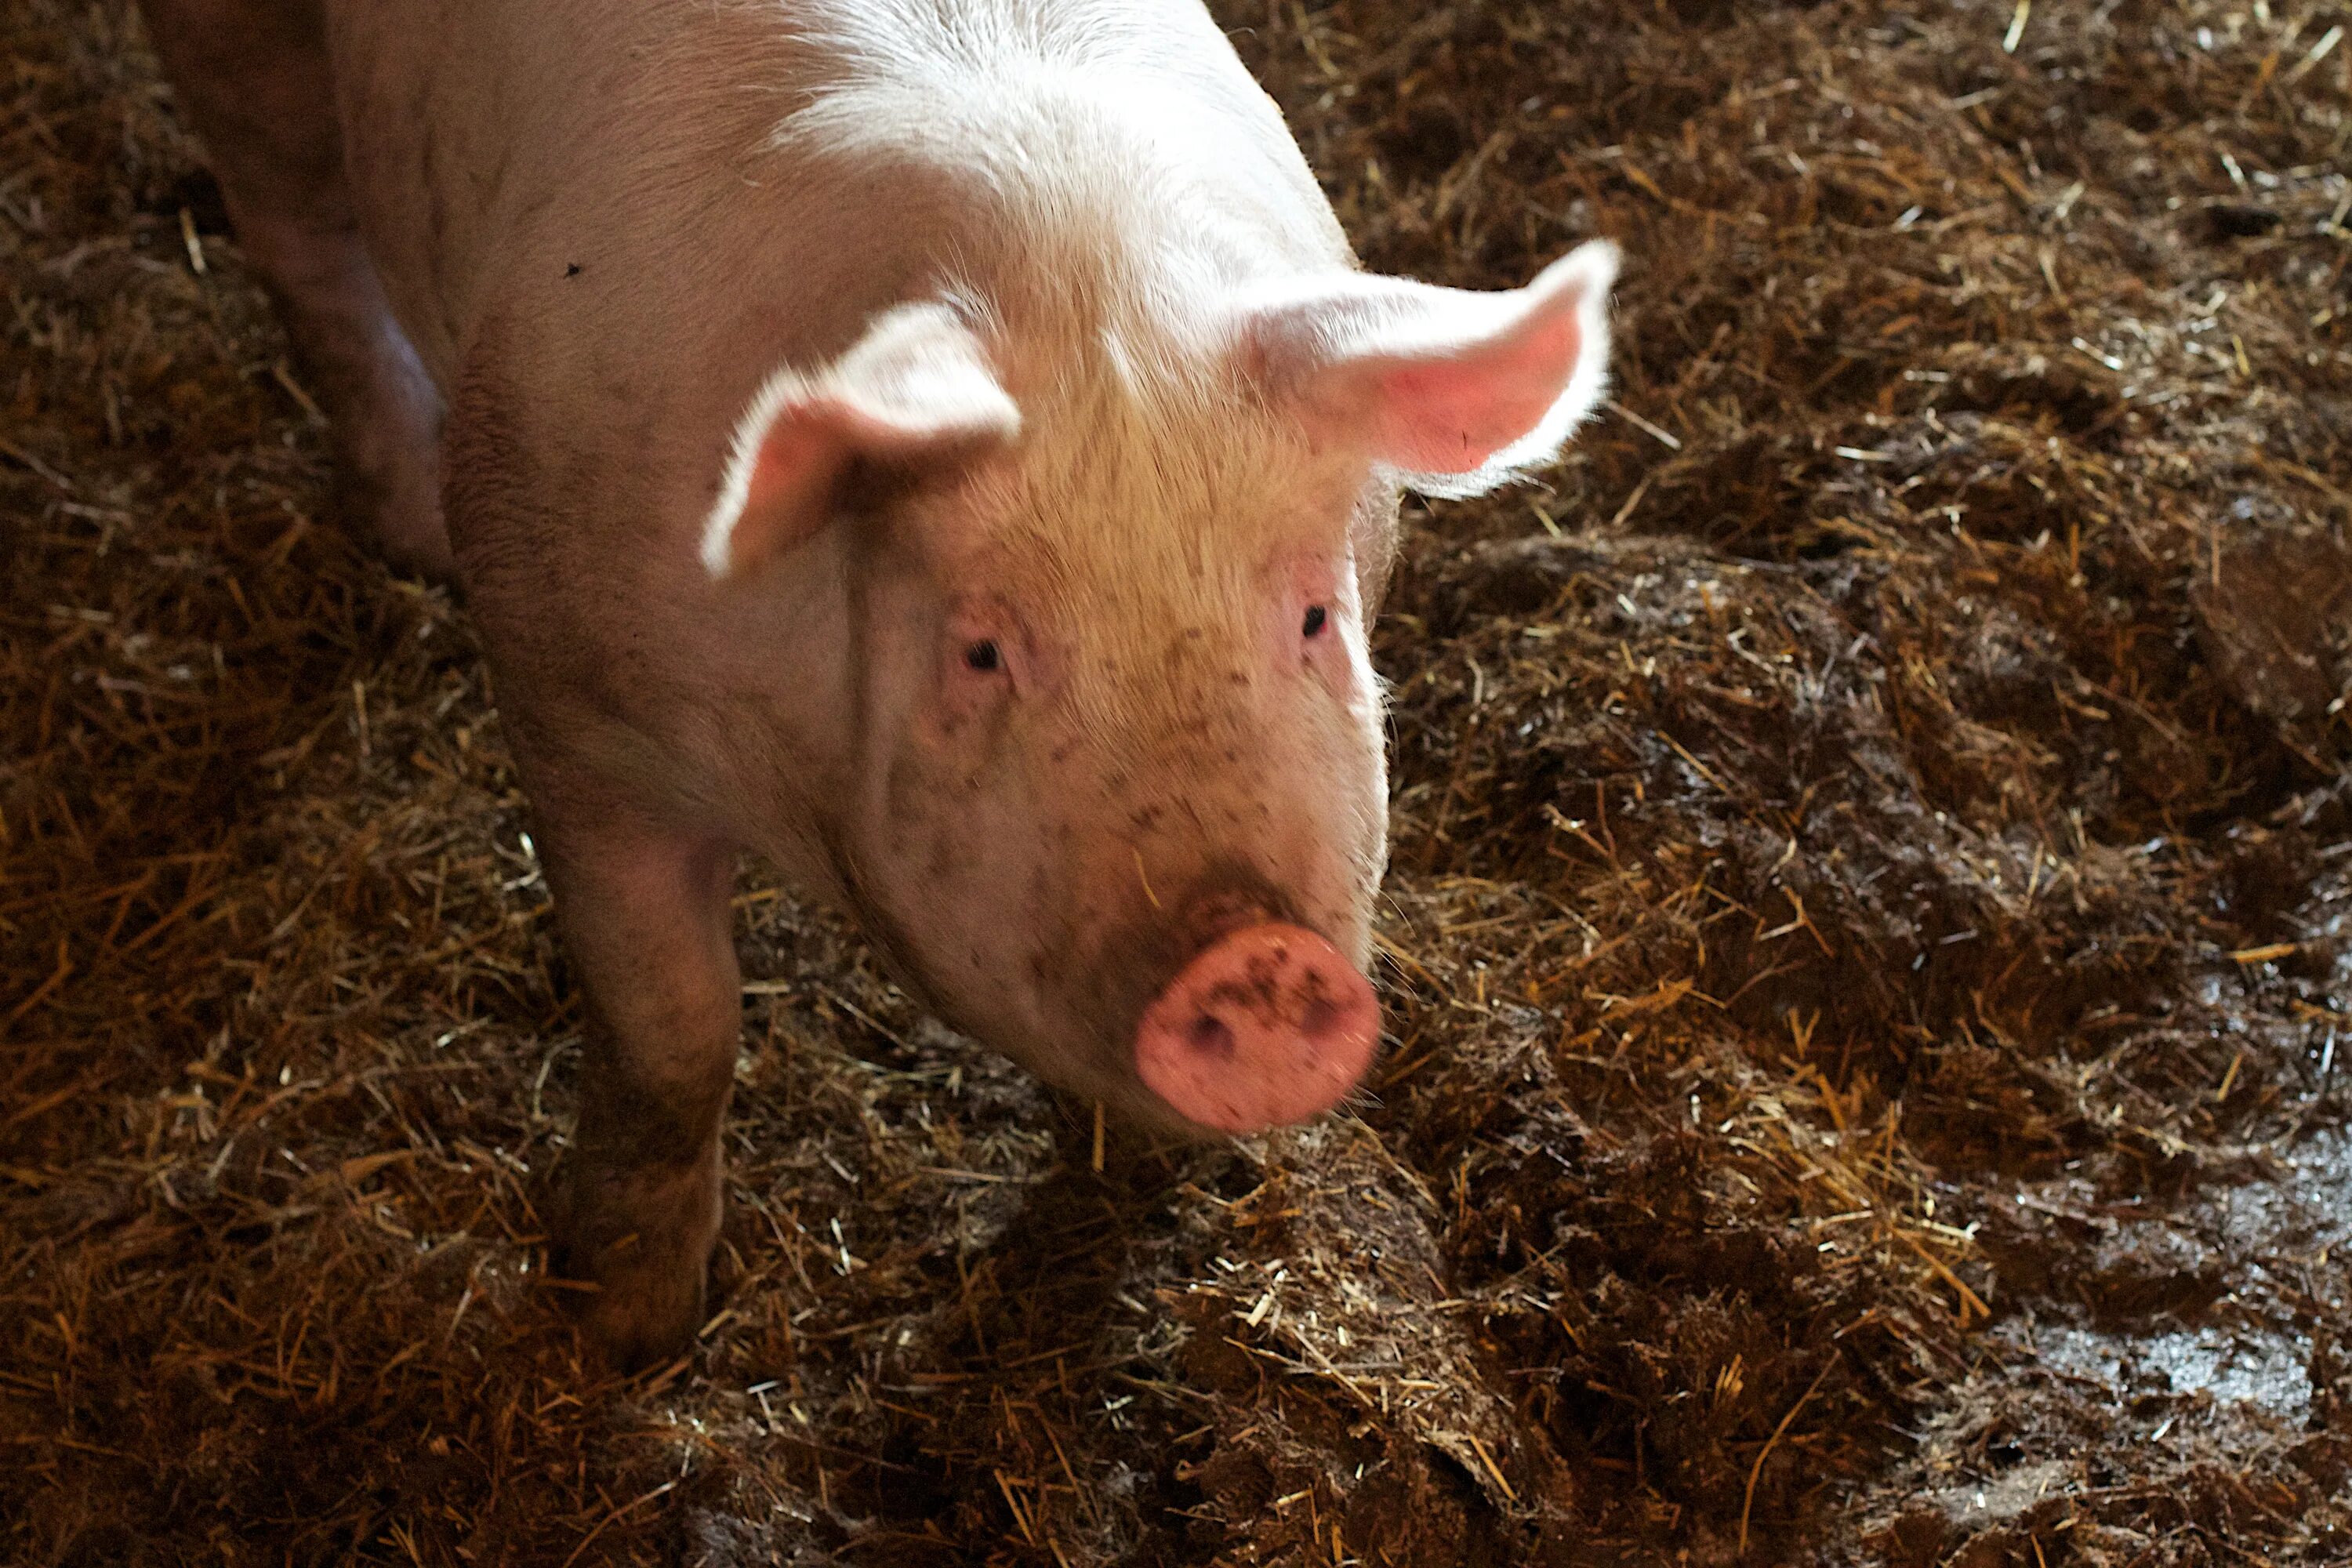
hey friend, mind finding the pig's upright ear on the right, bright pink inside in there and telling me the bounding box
[1242,240,1618,496]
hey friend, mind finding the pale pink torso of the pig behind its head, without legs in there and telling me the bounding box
[327,0,1350,895]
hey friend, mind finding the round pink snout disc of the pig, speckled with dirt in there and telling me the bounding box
[1136,924,1381,1133]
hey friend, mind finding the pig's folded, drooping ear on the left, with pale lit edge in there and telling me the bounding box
[703,303,1021,579]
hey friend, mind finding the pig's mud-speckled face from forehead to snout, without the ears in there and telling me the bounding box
[833,371,1395,1131]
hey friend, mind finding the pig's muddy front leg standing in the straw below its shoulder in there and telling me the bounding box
[541,799,743,1368]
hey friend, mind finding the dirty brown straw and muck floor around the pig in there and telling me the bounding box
[0,0,2352,1568]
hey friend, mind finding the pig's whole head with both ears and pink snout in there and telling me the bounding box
[703,247,1616,1133]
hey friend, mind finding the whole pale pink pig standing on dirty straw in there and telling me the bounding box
[143,0,1616,1366]
